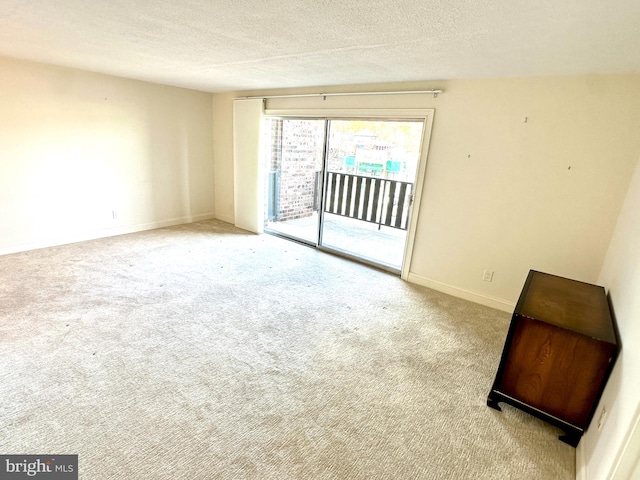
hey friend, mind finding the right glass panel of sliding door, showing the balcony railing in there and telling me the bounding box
[319,120,423,270]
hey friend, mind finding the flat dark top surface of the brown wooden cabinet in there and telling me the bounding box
[515,270,617,343]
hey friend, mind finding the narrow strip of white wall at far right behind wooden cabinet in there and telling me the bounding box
[579,156,640,480]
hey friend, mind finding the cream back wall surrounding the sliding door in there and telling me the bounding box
[214,75,640,310]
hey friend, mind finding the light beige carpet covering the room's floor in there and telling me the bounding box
[0,221,575,480]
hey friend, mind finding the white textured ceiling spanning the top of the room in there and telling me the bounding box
[0,0,640,91]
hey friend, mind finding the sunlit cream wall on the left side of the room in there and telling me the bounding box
[0,55,214,253]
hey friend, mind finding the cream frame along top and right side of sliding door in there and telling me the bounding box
[264,108,435,280]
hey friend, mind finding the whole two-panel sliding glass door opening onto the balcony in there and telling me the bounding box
[265,118,424,271]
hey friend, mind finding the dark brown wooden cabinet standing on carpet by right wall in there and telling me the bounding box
[487,270,619,447]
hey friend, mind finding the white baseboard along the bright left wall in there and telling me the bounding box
[0,213,215,255]
